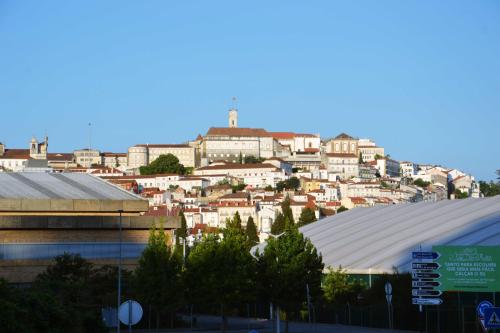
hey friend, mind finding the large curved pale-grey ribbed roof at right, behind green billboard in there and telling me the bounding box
[300,196,500,274]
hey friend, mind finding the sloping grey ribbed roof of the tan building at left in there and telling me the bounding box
[0,172,141,200]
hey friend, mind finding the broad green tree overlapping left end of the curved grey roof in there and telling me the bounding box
[258,223,324,332]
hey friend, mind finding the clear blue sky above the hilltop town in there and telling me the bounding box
[0,0,500,180]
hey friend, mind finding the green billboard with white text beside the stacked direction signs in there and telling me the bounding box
[432,246,500,292]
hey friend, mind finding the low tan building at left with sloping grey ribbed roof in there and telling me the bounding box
[0,173,179,283]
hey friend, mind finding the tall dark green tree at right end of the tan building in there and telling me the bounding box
[134,222,183,328]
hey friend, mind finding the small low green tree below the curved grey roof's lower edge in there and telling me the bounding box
[323,267,365,305]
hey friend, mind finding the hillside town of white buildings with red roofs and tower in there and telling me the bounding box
[0,109,480,238]
